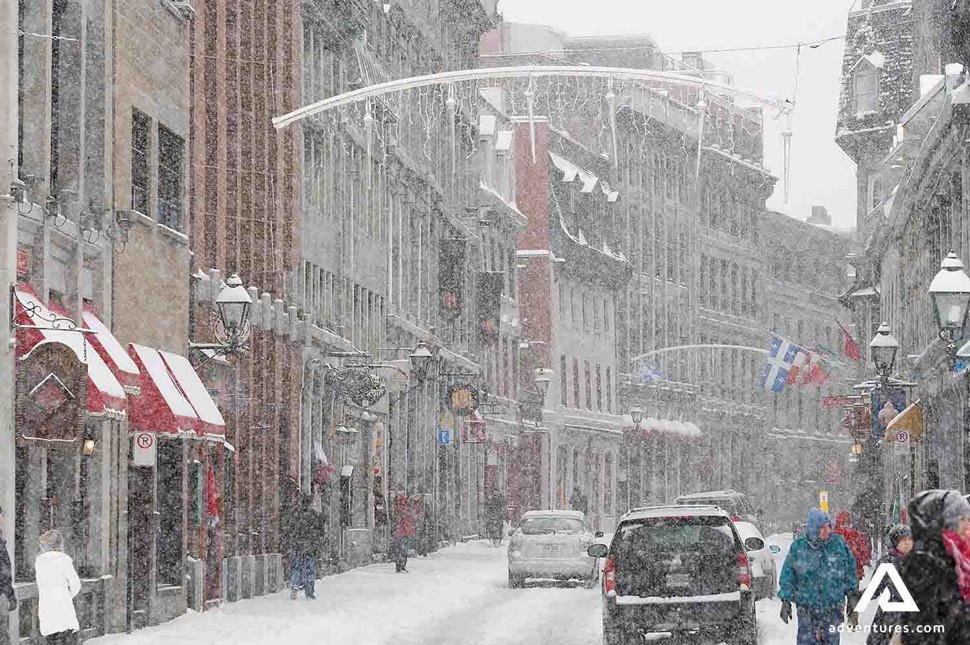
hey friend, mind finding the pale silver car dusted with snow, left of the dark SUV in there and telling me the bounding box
[509,510,603,589]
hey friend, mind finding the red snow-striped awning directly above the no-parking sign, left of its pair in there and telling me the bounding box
[128,343,199,434]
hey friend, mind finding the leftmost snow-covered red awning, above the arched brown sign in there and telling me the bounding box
[15,283,128,419]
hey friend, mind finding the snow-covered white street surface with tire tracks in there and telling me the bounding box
[91,542,865,645]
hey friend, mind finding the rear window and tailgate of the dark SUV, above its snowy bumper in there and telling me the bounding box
[610,516,742,596]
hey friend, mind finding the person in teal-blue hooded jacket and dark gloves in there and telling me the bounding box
[778,508,859,645]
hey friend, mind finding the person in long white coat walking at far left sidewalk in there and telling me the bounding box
[34,530,81,645]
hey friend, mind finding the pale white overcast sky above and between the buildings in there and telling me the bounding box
[499,0,855,228]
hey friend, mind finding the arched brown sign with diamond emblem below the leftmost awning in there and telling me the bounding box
[17,343,88,446]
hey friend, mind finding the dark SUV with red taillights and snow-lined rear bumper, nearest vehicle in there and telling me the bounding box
[587,504,758,645]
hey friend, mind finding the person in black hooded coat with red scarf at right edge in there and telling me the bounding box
[899,490,970,645]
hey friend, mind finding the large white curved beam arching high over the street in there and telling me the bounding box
[273,65,794,129]
